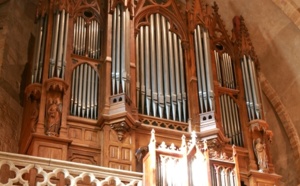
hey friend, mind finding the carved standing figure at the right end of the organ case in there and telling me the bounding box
[253,138,268,172]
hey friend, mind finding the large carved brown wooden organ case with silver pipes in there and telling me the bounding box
[20,0,280,185]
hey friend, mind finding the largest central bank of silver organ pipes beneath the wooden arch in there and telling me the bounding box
[136,13,187,121]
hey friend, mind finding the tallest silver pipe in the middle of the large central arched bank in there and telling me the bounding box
[155,14,164,118]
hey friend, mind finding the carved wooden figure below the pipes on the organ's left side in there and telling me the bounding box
[46,102,61,136]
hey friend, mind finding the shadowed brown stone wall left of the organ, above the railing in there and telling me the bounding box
[0,0,36,152]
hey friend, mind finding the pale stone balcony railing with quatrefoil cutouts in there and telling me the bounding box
[0,152,143,186]
